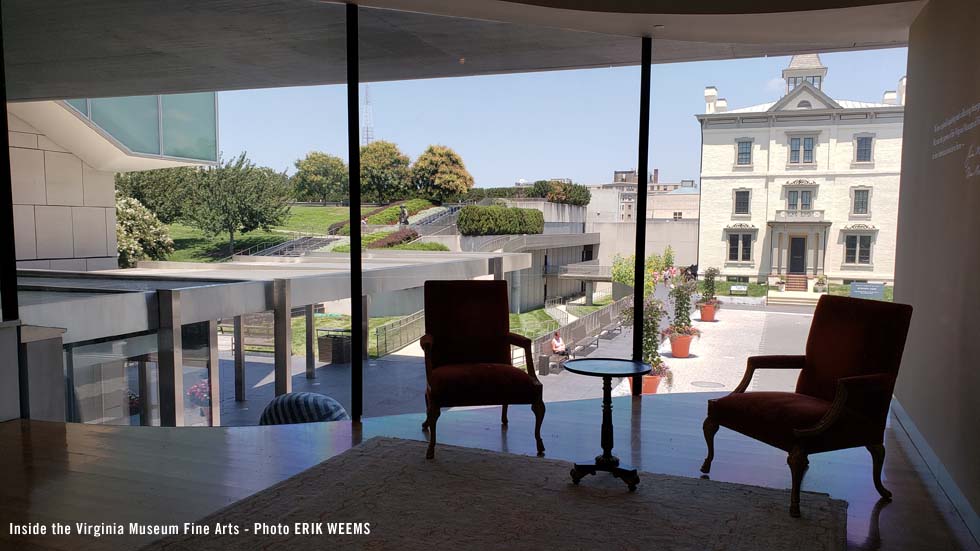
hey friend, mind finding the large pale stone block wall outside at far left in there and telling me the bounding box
[8,115,118,271]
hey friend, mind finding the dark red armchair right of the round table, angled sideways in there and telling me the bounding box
[701,295,912,517]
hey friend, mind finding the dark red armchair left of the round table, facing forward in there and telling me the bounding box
[422,280,545,459]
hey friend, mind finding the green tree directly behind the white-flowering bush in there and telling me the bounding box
[116,167,197,224]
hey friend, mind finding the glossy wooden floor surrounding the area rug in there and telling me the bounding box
[0,393,980,550]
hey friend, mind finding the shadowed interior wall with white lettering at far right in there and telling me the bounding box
[895,0,980,538]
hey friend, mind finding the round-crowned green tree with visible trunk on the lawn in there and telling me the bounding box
[185,153,290,253]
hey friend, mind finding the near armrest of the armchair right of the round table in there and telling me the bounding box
[793,373,895,437]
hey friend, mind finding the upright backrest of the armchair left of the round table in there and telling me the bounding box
[425,280,511,368]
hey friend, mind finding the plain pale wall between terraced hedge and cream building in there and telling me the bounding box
[585,220,698,266]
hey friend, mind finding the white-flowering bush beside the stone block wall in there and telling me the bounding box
[116,194,174,268]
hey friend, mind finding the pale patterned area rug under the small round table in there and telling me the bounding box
[144,438,847,551]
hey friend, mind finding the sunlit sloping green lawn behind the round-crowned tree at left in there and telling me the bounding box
[167,205,373,262]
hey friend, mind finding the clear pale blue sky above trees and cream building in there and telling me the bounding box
[219,48,906,187]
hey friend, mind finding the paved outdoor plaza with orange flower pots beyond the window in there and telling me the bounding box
[220,305,812,426]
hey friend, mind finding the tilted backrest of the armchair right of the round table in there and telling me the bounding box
[796,295,912,400]
